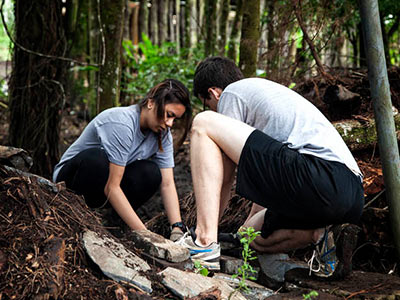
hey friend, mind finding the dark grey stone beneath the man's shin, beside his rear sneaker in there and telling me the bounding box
[258,253,308,283]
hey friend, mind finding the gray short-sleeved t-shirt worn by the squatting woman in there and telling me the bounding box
[53,105,174,181]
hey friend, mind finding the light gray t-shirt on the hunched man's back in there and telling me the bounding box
[217,78,362,178]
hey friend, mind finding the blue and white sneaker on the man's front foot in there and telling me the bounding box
[175,232,221,271]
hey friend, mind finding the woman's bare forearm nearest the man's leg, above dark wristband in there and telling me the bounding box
[160,168,182,224]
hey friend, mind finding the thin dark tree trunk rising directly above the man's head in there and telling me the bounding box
[204,0,217,56]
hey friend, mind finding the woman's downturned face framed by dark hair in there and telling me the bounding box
[146,100,186,133]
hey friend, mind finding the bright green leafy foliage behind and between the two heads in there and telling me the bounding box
[122,35,203,107]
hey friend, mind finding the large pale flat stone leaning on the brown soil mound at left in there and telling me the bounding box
[82,230,152,293]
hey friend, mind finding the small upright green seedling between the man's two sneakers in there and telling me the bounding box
[232,227,261,292]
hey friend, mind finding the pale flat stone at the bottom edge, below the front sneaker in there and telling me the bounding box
[159,268,246,300]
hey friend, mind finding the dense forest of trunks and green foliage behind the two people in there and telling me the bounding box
[0,0,400,177]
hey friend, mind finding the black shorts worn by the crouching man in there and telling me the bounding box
[236,130,364,237]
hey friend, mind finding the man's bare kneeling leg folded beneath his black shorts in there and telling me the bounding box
[243,209,324,253]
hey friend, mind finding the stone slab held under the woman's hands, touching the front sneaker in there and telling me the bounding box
[129,230,190,262]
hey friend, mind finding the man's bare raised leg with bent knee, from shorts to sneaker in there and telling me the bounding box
[190,111,254,246]
